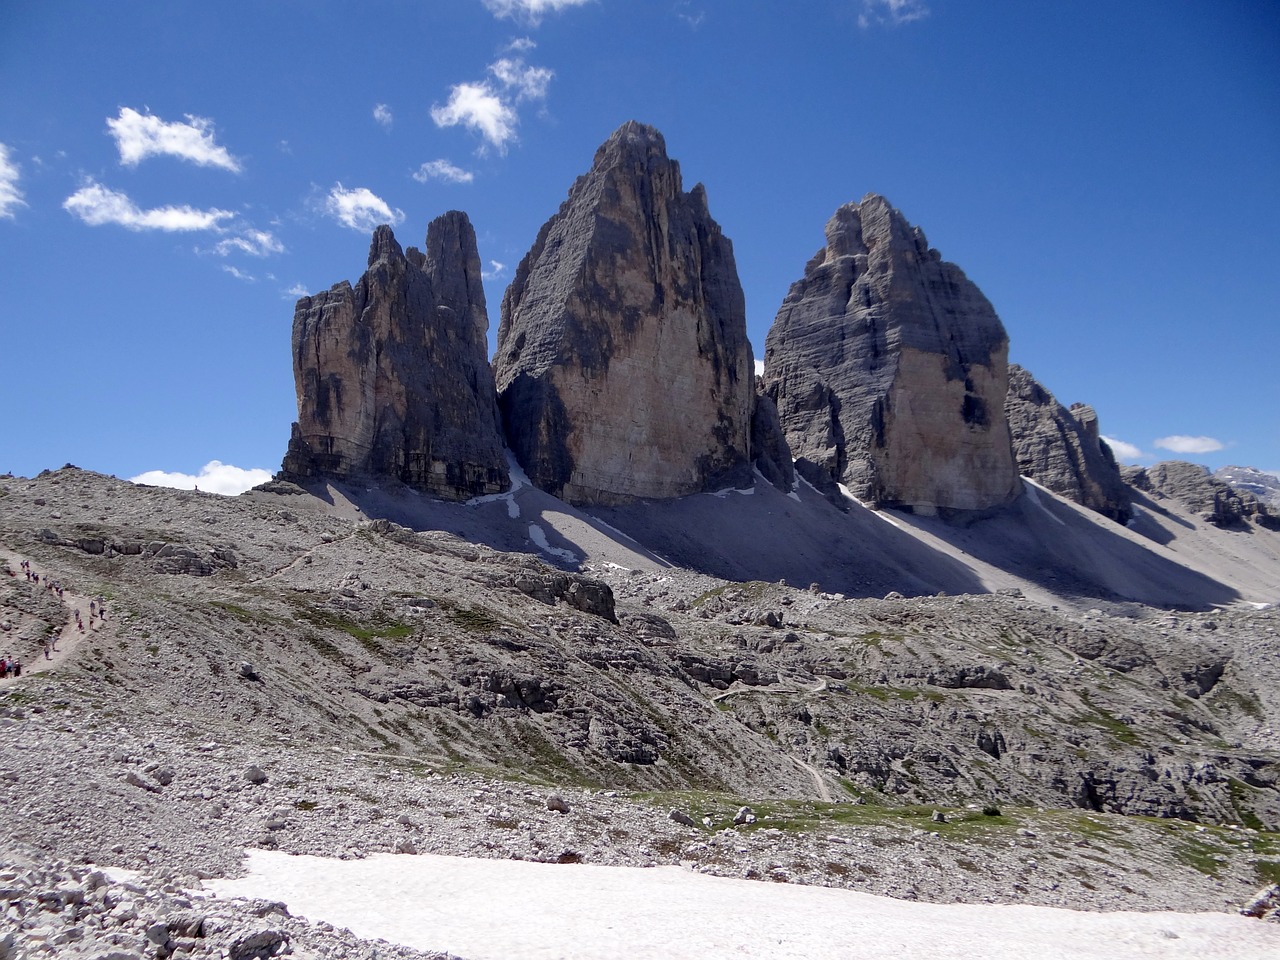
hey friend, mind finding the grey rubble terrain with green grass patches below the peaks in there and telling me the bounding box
[0,467,1280,960]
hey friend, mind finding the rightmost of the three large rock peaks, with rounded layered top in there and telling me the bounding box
[764,195,1021,513]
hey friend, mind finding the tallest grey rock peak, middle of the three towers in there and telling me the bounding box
[494,123,754,504]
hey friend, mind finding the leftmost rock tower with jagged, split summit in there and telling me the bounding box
[280,211,508,499]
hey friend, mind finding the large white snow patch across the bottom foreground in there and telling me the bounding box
[205,850,1280,960]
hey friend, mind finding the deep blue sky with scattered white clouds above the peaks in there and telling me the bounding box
[0,0,1280,491]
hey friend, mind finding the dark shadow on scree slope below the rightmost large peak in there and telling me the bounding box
[893,481,1240,609]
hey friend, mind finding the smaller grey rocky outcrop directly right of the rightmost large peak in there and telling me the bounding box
[1005,364,1133,524]
